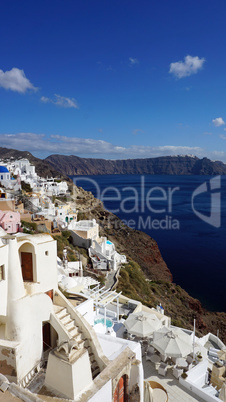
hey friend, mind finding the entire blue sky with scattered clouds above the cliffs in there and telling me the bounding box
[0,0,226,162]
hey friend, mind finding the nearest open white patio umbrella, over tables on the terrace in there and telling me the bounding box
[151,327,192,357]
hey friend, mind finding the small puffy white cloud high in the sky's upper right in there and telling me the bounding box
[169,55,205,78]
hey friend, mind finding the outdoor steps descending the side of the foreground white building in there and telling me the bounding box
[54,305,100,379]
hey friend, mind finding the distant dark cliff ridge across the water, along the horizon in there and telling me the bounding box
[45,155,226,175]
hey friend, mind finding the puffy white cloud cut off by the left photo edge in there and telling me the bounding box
[0,67,38,93]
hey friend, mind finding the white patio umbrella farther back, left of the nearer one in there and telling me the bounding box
[124,311,162,338]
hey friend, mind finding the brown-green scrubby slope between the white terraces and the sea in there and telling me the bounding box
[117,261,226,342]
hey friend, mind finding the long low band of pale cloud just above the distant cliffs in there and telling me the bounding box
[0,133,226,162]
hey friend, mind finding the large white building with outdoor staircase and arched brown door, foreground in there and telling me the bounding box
[0,231,143,402]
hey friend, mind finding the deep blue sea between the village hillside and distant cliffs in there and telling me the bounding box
[70,175,226,311]
